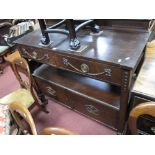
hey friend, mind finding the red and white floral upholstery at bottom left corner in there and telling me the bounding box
[0,104,11,135]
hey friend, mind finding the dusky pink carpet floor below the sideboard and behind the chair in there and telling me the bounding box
[0,66,116,135]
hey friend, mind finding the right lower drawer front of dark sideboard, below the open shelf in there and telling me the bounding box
[67,92,118,129]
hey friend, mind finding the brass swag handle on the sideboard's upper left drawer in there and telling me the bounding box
[22,48,49,61]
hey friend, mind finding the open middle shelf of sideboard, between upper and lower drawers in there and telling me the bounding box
[33,64,120,110]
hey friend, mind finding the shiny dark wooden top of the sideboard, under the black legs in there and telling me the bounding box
[16,27,149,68]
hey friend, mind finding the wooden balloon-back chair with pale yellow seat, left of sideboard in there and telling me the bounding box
[0,57,45,110]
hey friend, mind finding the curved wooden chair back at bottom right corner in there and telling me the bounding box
[128,102,155,135]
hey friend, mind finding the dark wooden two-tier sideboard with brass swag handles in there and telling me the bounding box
[16,22,150,133]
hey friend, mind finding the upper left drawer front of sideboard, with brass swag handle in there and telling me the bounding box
[20,46,56,66]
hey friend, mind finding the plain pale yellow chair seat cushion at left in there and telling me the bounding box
[0,88,34,108]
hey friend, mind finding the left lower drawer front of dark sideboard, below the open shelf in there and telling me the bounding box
[34,77,73,108]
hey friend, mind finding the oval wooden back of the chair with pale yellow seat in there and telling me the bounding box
[12,57,32,91]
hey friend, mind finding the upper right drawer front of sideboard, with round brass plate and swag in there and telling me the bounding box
[56,54,121,85]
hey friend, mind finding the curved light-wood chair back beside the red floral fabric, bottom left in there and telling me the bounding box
[9,102,37,135]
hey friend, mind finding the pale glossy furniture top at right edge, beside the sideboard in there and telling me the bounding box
[132,40,155,98]
